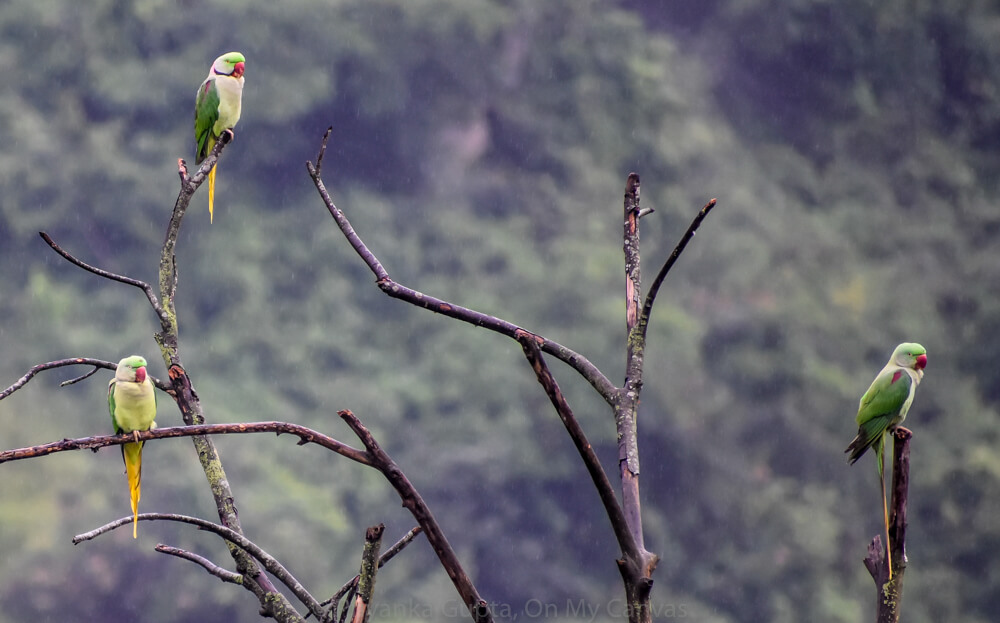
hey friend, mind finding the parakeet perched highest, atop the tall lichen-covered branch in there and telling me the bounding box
[194,52,246,222]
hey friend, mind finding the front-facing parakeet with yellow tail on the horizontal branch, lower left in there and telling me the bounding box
[108,355,156,538]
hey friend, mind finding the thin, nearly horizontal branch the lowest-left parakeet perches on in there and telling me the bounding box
[0,422,375,467]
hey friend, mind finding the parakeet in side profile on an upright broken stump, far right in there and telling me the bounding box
[844,342,927,580]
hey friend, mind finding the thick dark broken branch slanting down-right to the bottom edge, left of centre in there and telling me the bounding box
[339,409,493,623]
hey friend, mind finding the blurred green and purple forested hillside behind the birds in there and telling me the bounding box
[0,0,1000,623]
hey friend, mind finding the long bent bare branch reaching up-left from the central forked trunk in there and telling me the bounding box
[306,140,616,403]
